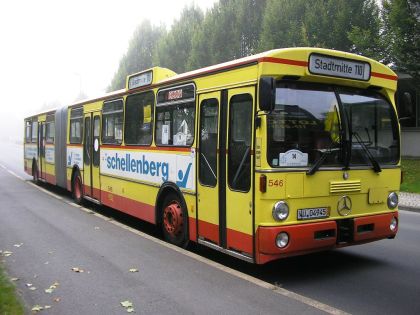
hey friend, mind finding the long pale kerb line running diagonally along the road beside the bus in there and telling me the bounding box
[4,164,348,315]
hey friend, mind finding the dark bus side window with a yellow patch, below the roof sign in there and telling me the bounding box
[124,91,155,145]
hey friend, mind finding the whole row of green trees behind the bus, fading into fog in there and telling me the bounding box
[108,0,420,94]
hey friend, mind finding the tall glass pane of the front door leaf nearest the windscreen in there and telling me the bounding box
[228,94,252,191]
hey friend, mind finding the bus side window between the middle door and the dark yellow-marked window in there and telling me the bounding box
[102,99,124,144]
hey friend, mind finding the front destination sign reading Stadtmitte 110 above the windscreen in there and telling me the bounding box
[309,54,370,81]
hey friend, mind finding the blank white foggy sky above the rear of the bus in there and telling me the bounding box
[0,0,216,141]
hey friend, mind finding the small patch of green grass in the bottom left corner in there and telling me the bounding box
[0,265,24,315]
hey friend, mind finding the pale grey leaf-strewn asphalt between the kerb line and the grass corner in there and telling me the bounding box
[0,143,330,315]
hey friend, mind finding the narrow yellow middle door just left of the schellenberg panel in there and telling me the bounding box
[83,112,101,201]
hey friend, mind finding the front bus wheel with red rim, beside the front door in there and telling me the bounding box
[161,193,189,248]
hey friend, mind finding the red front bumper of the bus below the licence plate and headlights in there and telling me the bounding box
[256,212,398,264]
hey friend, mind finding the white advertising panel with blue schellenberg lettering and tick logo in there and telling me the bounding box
[100,148,195,190]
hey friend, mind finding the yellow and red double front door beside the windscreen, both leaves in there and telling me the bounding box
[197,86,255,258]
